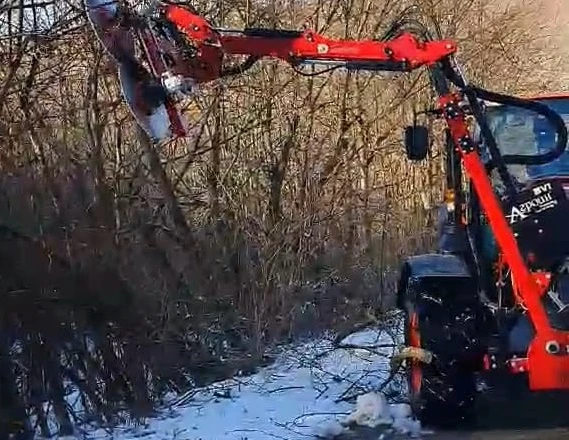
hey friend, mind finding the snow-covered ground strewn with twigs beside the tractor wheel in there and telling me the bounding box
[55,312,430,440]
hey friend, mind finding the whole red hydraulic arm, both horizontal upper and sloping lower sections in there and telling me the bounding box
[155,5,569,390]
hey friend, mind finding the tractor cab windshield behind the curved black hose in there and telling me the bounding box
[476,96,569,184]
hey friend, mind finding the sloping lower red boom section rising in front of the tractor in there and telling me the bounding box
[439,94,569,390]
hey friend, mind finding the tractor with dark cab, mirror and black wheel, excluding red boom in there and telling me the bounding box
[397,94,569,427]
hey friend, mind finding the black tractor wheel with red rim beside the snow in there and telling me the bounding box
[405,280,478,429]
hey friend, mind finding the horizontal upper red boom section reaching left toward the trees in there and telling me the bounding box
[163,5,456,82]
